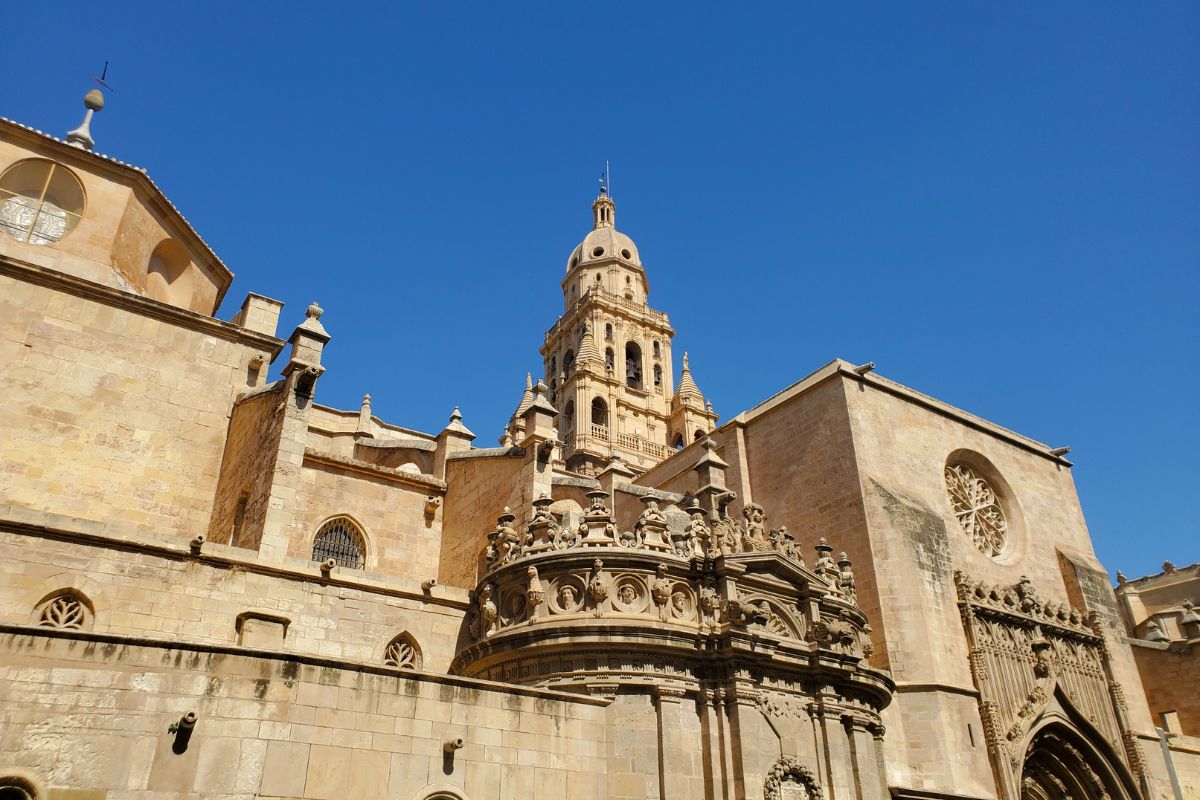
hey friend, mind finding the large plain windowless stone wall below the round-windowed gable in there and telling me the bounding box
[0,268,276,537]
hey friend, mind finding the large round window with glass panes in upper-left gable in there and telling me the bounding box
[0,158,85,245]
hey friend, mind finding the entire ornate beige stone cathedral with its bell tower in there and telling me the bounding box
[0,90,1200,800]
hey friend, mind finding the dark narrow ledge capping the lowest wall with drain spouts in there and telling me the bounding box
[0,622,611,705]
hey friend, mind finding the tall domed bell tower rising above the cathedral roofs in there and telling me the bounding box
[541,188,716,475]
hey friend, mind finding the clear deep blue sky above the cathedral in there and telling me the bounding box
[0,1,1200,576]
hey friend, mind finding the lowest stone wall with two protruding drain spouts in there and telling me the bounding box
[0,626,604,800]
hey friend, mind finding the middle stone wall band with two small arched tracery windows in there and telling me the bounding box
[0,520,467,672]
